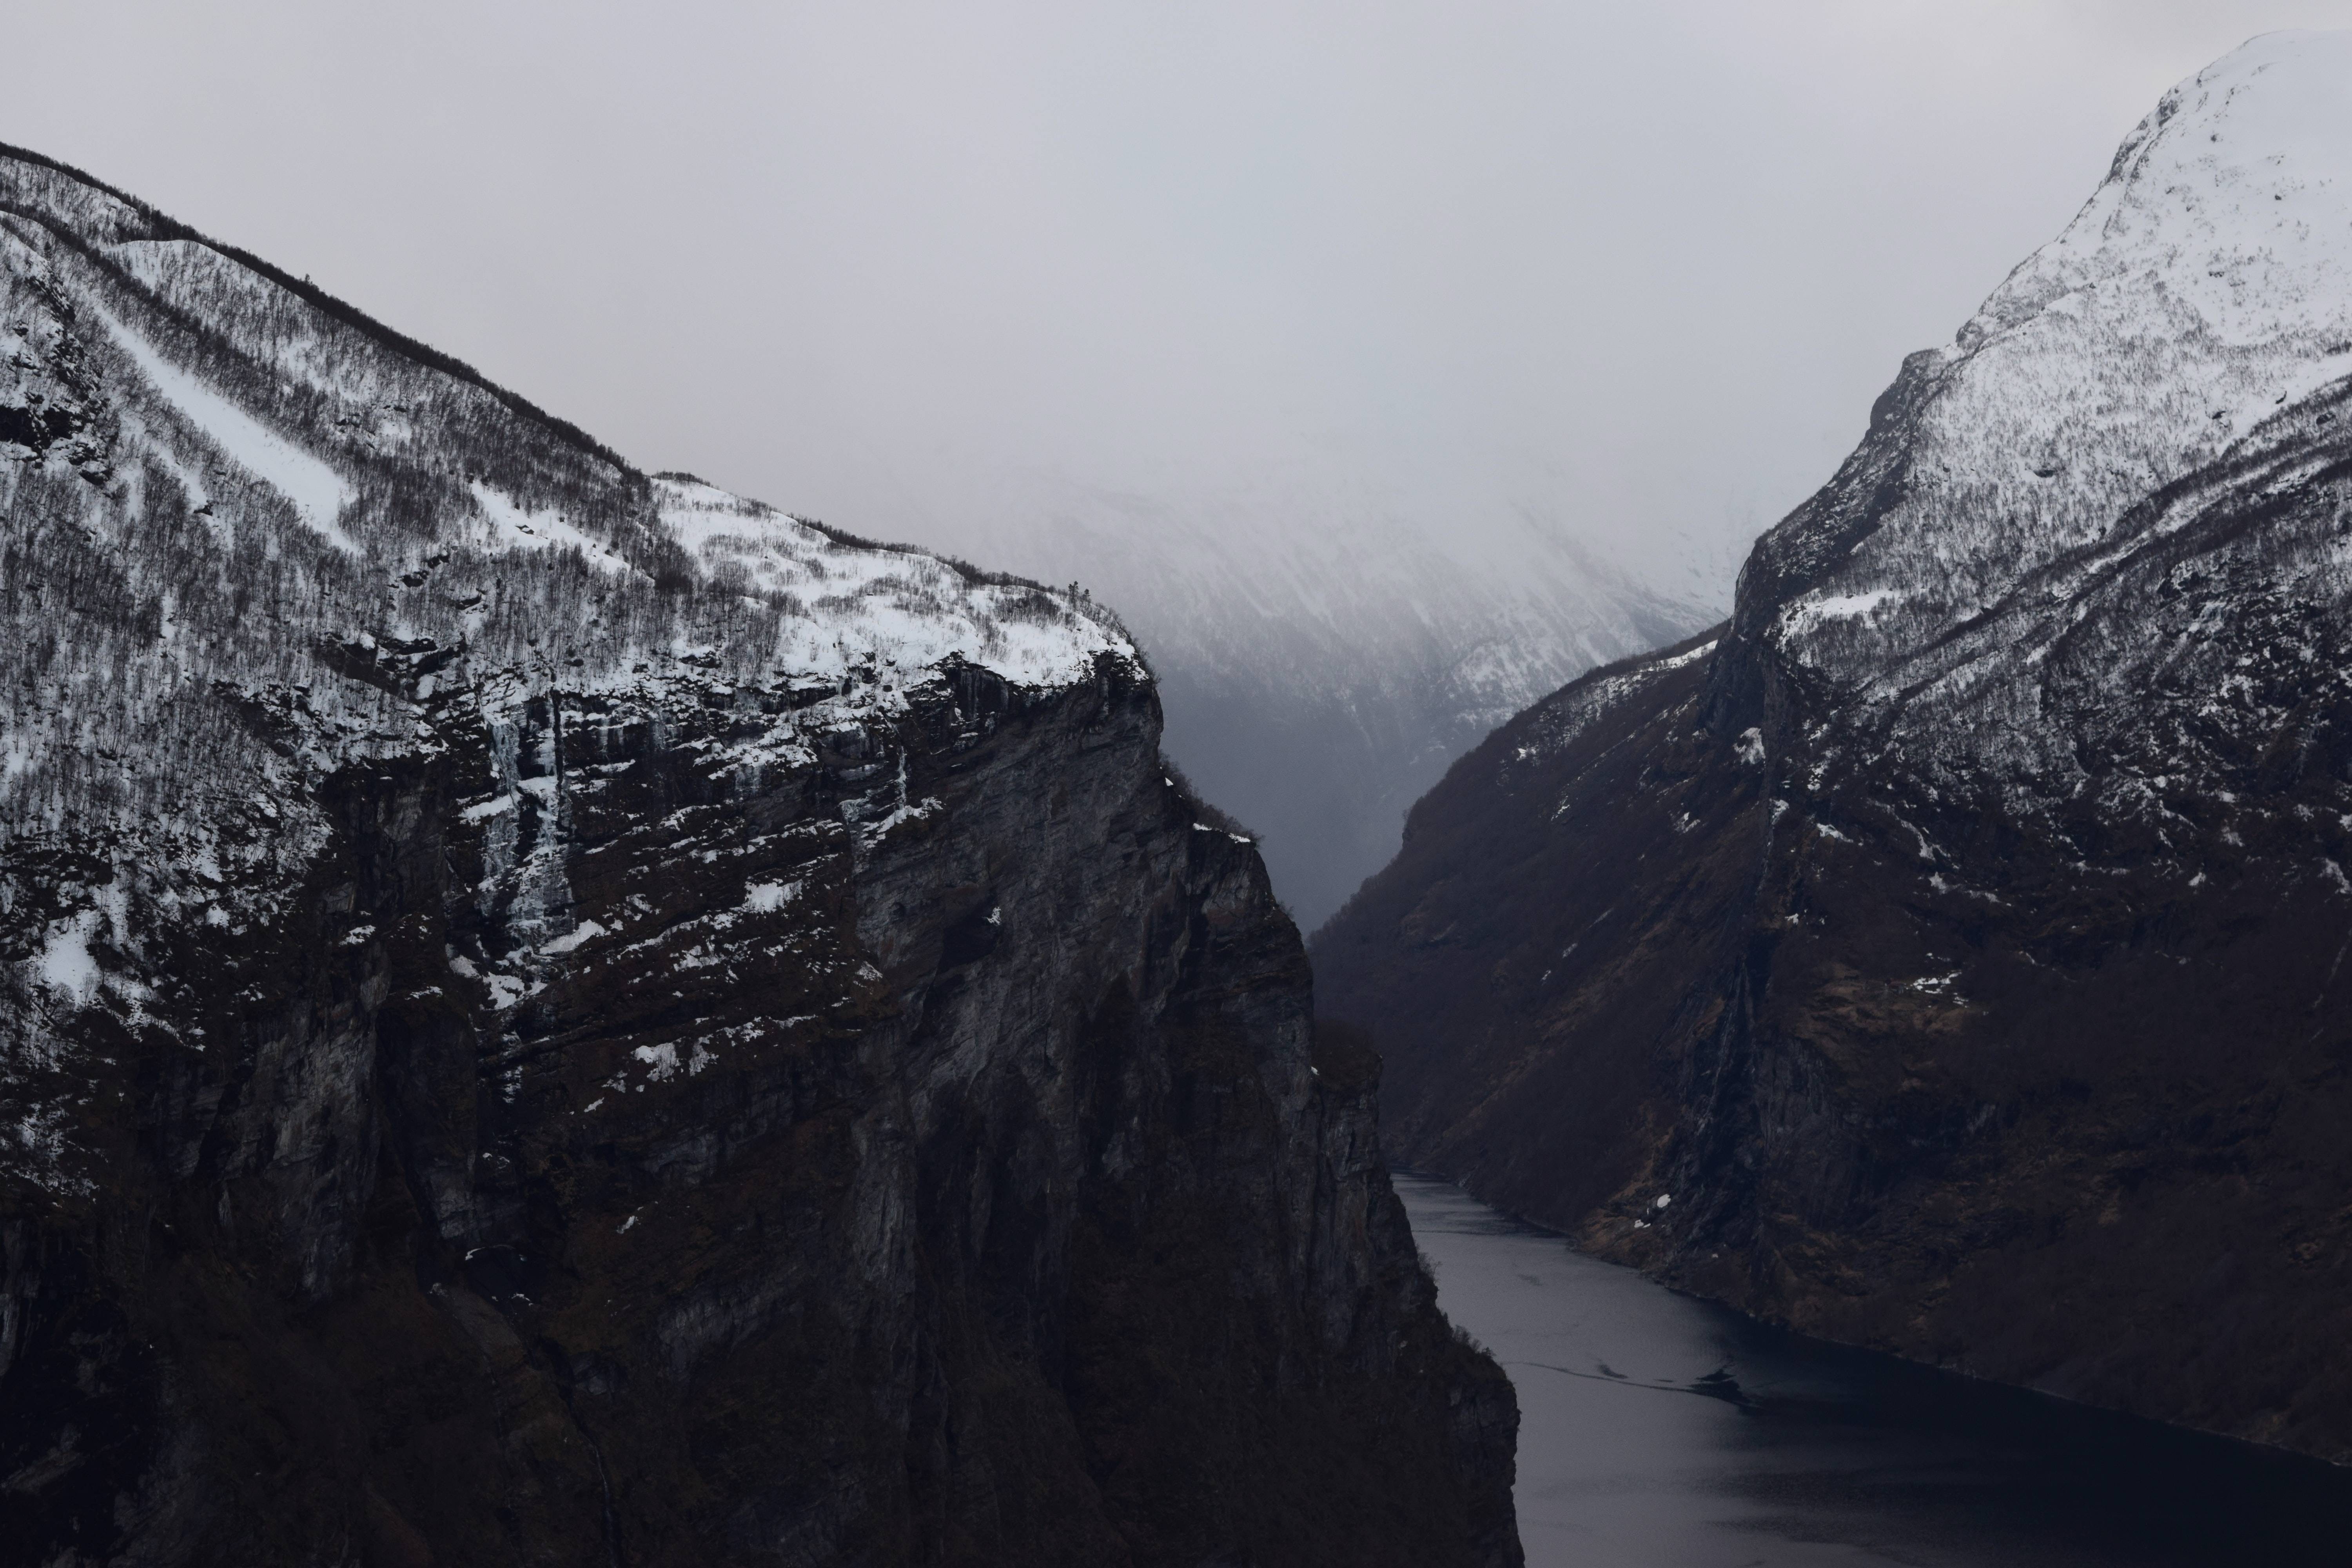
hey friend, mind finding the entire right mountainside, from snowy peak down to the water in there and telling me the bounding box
[1315,33,2352,1460]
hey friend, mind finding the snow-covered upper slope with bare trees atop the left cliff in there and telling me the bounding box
[0,153,1131,1189]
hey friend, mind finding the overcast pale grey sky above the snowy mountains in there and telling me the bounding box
[0,0,2352,595]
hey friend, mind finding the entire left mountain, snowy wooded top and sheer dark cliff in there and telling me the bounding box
[0,144,1517,1563]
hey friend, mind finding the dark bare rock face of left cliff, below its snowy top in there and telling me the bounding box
[0,663,1517,1568]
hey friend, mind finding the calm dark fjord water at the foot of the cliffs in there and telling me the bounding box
[1397,1176,2352,1568]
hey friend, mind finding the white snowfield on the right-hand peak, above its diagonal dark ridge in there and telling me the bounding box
[1769,33,2352,701]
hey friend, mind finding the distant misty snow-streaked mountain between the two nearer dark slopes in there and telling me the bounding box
[913,470,1712,929]
